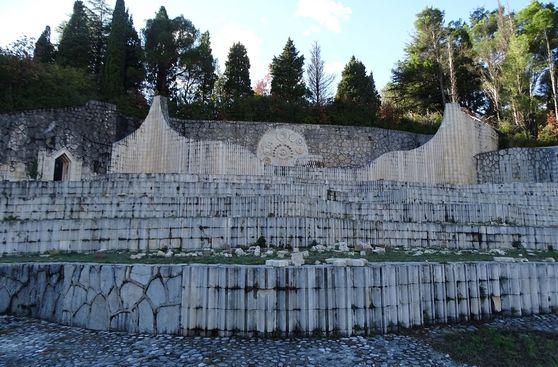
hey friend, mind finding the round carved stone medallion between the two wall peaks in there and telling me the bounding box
[257,128,308,166]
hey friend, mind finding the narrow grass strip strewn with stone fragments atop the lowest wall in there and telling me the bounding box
[0,249,558,265]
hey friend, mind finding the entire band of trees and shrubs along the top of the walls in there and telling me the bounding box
[0,0,558,145]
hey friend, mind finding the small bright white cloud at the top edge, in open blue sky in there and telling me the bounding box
[296,0,353,33]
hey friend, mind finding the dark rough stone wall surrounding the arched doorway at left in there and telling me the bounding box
[0,101,139,181]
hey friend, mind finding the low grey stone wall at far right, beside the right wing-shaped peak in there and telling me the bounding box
[476,147,558,183]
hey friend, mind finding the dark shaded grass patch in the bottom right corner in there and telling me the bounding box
[429,326,558,367]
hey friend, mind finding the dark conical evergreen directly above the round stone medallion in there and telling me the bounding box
[271,38,307,104]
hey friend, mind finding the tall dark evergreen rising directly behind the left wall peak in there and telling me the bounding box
[143,6,198,96]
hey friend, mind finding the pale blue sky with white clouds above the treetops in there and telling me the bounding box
[0,0,530,89]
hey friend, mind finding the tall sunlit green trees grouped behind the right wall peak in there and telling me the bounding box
[390,0,558,145]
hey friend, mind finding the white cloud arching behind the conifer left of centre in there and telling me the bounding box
[211,24,267,84]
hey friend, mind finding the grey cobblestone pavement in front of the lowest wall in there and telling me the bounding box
[0,315,558,367]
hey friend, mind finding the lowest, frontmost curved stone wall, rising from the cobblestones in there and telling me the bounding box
[0,262,558,335]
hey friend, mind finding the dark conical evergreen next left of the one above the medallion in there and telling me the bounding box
[223,43,254,104]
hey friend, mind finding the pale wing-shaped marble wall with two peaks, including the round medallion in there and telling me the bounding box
[111,97,498,184]
